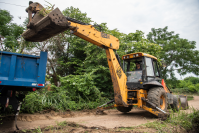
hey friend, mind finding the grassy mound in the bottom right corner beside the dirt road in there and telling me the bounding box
[116,108,199,133]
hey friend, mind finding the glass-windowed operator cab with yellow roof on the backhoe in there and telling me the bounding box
[122,52,161,88]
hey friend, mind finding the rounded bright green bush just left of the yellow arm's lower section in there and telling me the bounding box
[60,73,101,101]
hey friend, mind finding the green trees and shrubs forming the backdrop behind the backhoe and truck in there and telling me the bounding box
[0,3,199,113]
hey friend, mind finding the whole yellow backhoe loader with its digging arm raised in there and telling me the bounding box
[22,2,188,118]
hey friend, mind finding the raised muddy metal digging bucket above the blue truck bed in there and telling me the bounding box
[22,8,69,42]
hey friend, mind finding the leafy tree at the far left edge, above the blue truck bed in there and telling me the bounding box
[0,10,24,52]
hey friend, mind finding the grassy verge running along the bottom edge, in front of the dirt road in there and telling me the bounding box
[17,108,199,133]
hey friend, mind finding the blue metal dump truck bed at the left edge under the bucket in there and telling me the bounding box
[0,51,47,88]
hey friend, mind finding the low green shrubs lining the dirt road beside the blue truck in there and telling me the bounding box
[21,73,108,113]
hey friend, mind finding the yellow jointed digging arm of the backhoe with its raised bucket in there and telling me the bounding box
[22,3,128,107]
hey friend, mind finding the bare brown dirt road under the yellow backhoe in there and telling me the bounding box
[0,96,199,132]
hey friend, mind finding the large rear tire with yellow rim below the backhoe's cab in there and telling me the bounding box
[147,87,168,112]
